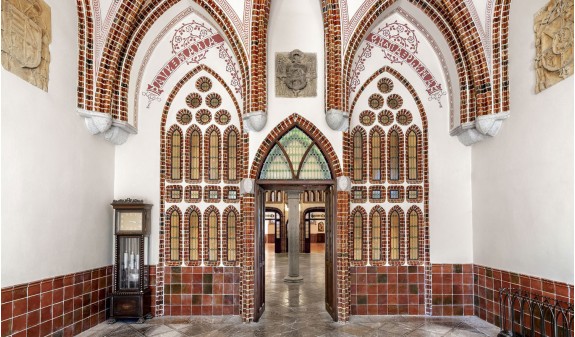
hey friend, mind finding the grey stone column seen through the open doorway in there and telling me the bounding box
[284,191,303,283]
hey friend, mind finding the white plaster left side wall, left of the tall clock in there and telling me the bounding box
[1,0,114,287]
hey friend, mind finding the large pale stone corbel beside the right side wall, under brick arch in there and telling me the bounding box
[451,112,509,146]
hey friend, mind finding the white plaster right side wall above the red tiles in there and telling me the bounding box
[472,0,574,284]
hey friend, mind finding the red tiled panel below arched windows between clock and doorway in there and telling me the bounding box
[161,267,240,316]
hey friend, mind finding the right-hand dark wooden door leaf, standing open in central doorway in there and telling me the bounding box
[325,185,337,321]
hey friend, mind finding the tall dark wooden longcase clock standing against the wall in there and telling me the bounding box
[108,199,152,323]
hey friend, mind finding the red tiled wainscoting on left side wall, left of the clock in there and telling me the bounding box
[2,266,112,337]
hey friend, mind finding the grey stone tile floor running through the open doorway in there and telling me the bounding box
[79,247,499,337]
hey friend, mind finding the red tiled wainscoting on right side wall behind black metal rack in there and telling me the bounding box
[474,265,574,325]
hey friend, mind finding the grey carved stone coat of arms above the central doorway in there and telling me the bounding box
[276,49,317,97]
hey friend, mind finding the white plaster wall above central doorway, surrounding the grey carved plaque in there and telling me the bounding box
[249,0,343,169]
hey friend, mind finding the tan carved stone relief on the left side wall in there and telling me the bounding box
[2,0,52,91]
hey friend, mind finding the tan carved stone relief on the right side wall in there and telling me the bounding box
[534,0,573,93]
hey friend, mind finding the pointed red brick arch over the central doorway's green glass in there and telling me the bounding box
[249,113,343,179]
